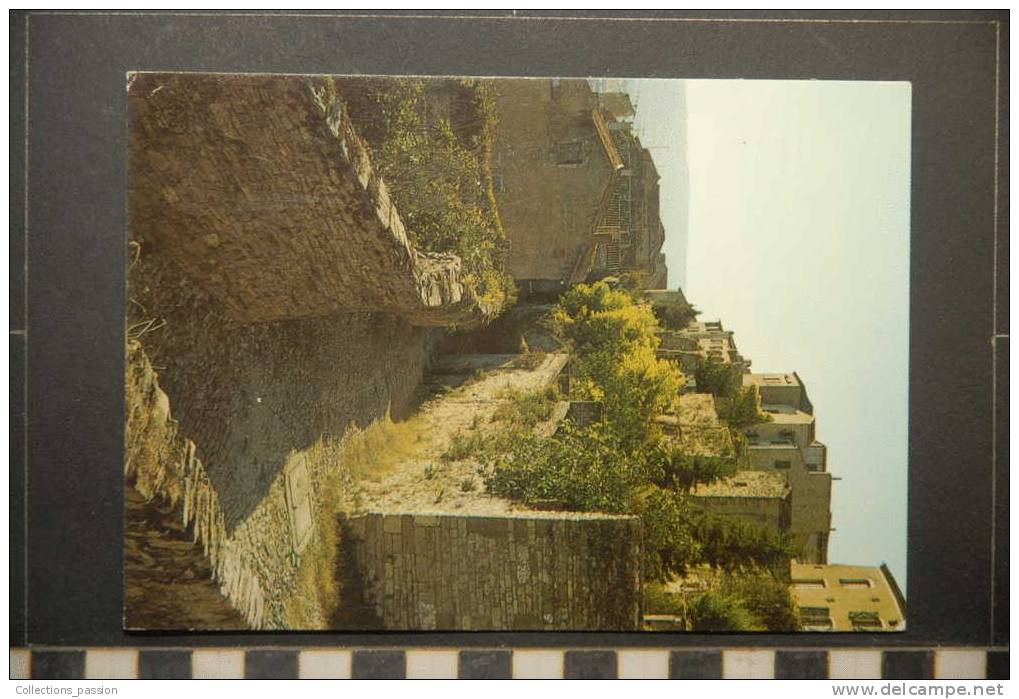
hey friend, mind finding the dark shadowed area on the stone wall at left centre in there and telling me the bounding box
[128,255,435,531]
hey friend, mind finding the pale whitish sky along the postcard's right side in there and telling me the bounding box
[626,80,910,590]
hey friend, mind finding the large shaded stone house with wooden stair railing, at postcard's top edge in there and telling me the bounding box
[492,79,666,294]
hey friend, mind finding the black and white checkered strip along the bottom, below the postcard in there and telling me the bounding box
[10,648,1009,680]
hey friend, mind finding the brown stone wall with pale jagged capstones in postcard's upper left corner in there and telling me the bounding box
[128,73,484,325]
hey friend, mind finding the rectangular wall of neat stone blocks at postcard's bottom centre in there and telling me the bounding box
[344,513,642,631]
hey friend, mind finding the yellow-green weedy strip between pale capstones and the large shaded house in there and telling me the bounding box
[336,77,516,309]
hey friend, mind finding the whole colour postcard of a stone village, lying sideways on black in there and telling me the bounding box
[123,72,911,633]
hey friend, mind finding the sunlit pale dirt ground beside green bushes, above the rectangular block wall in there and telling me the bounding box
[357,355,567,515]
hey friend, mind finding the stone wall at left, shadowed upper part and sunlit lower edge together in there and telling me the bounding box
[125,251,437,629]
